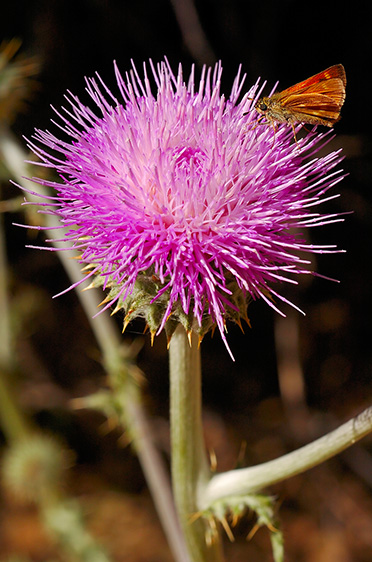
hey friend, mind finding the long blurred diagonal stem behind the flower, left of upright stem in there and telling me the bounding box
[0,129,190,562]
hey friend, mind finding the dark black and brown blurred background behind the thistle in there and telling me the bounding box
[0,0,372,562]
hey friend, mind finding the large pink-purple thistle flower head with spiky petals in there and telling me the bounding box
[25,60,342,354]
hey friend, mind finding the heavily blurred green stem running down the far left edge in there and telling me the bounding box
[0,128,110,562]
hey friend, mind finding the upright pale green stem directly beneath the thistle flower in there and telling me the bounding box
[169,326,223,562]
